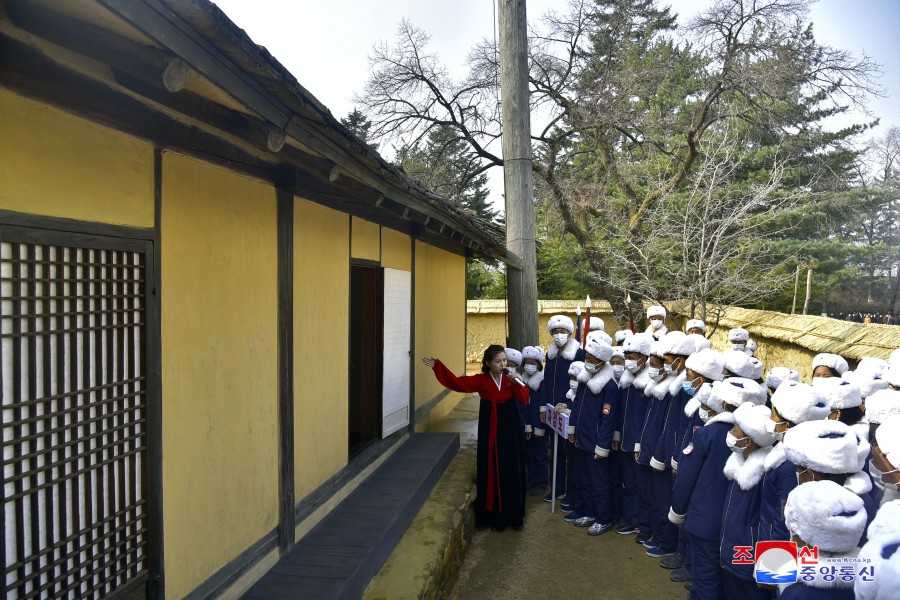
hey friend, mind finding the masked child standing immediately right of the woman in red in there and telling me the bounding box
[522,346,547,496]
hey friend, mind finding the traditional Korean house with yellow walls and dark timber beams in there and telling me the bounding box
[0,0,515,598]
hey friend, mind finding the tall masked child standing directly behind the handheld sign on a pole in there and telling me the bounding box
[541,315,584,502]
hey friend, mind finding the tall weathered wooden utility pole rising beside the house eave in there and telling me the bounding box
[497,0,538,348]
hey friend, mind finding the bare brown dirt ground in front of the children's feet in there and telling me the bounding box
[451,474,688,600]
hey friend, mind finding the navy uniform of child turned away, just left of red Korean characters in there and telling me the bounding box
[669,413,734,600]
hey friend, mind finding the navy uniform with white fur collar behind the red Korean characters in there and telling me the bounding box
[719,446,774,600]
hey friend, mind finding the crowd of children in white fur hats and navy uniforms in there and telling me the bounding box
[506,306,900,600]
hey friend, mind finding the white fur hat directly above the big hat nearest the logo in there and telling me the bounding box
[783,419,869,475]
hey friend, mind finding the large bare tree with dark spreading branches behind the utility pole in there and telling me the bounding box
[357,0,881,318]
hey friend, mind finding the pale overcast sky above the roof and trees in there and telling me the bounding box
[213,0,900,205]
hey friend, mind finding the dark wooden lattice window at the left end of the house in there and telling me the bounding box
[0,235,148,598]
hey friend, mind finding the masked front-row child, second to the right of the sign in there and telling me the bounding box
[613,333,653,543]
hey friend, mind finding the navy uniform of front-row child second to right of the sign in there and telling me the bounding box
[613,366,650,533]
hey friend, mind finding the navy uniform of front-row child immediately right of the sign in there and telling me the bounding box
[575,364,619,524]
